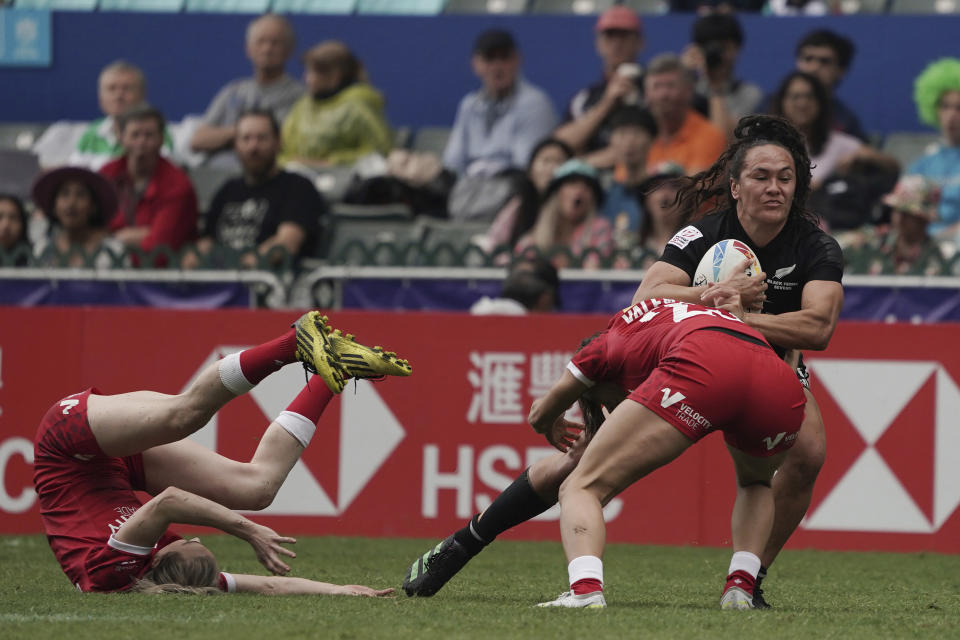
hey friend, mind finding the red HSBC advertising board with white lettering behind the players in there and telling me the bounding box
[0,308,960,552]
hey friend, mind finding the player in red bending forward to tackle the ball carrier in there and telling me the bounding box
[529,285,805,609]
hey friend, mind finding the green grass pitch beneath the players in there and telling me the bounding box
[0,536,960,640]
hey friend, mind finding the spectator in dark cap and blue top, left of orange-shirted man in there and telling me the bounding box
[601,105,657,249]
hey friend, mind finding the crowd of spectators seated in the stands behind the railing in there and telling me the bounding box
[0,6,960,275]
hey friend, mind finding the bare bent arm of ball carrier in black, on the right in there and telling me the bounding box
[743,280,843,351]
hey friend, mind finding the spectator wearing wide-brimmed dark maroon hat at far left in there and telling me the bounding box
[32,167,123,267]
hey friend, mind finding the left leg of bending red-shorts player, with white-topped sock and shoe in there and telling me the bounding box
[540,400,693,607]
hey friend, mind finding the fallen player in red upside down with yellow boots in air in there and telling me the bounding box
[34,311,411,596]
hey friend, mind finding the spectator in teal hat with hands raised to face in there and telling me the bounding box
[516,160,613,268]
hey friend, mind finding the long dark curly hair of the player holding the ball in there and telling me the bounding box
[677,116,819,224]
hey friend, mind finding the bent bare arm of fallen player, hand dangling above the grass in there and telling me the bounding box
[113,487,297,573]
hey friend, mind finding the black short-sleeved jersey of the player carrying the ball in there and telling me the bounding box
[660,209,843,314]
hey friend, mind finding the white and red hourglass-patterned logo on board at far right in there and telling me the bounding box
[804,358,960,533]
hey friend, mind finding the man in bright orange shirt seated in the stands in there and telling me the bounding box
[644,53,727,174]
